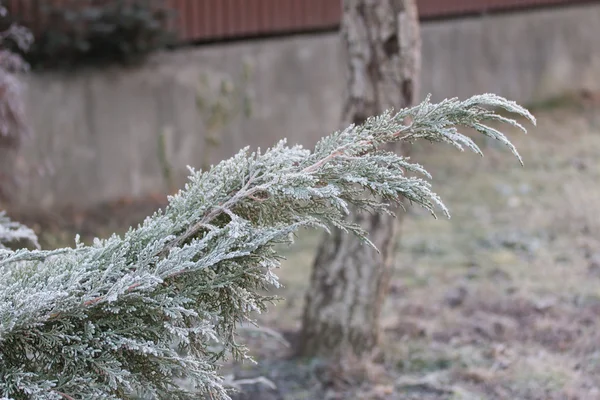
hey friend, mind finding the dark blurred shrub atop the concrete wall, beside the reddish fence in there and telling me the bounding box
[7,0,176,69]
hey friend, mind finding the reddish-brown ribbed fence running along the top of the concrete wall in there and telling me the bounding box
[5,0,598,42]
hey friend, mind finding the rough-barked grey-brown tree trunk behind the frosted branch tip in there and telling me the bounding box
[298,0,421,358]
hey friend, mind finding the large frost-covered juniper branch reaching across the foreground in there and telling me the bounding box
[0,95,535,400]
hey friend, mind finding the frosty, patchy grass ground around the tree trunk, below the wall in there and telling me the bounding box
[16,100,600,400]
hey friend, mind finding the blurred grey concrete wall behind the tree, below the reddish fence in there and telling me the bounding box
[10,5,600,208]
